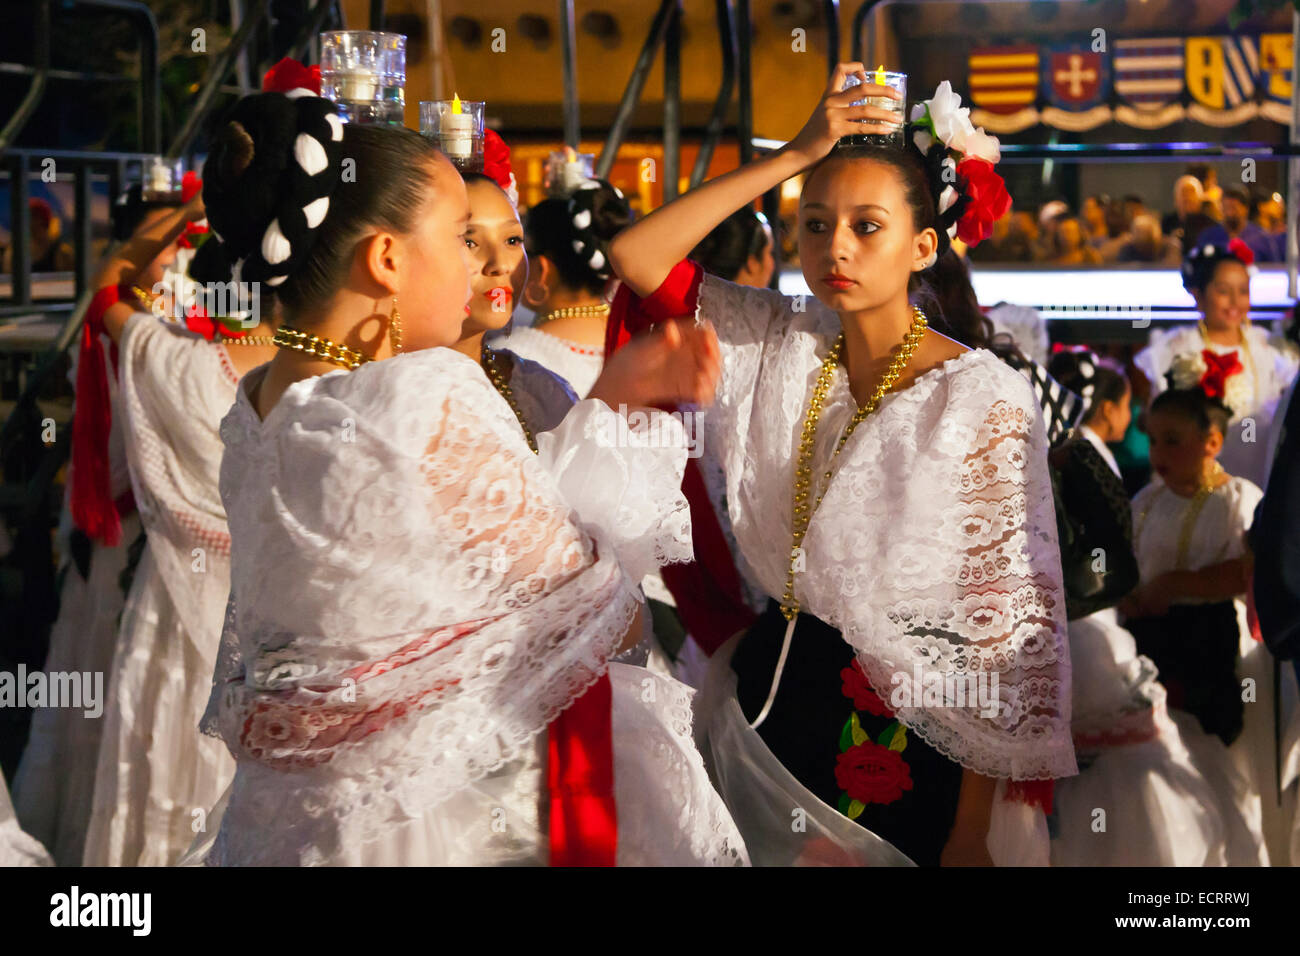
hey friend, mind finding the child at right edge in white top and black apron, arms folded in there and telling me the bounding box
[1119,369,1295,865]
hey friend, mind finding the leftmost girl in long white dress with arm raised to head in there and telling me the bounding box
[83,184,274,866]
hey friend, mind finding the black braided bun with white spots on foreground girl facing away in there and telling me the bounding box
[190,90,343,287]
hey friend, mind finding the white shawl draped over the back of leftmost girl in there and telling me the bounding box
[118,312,238,661]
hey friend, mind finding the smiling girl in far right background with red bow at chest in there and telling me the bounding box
[1134,239,1297,485]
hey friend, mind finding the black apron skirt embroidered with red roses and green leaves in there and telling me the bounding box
[732,601,962,866]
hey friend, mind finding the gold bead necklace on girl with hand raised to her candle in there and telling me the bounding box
[781,306,928,620]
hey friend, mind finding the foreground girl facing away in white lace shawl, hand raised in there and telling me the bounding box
[188,95,745,864]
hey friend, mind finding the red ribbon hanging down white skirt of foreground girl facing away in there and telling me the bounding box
[547,674,619,866]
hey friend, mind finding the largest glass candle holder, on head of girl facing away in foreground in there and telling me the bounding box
[320,30,406,126]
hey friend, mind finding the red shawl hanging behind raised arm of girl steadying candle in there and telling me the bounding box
[605,259,757,654]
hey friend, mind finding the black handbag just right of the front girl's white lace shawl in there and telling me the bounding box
[1048,437,1139,620]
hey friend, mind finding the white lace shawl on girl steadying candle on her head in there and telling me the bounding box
[698,276,1076,779]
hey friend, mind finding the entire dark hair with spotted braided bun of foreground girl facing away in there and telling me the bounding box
[190,92,437,317]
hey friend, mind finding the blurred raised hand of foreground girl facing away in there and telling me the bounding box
[588,319,722,411]
